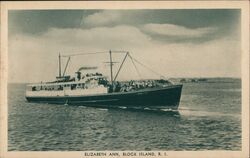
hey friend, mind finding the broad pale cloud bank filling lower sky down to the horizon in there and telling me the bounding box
[8,25,241,82]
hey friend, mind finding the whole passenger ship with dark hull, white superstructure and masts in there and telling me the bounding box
[26,51,182,110]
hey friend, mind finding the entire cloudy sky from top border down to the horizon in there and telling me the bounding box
[8,9,241,83]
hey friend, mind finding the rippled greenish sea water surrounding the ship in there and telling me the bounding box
[8,79,241,151]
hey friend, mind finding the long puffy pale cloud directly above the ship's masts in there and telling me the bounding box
[42,25,150,49]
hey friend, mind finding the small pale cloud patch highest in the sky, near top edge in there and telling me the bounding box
[82,10,121,26]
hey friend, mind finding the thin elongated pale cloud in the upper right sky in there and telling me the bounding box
[143,23,216,38]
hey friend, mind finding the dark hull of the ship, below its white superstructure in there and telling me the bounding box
[26,85,182,109]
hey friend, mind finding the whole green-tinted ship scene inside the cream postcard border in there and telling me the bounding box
[0,0,249,156]
